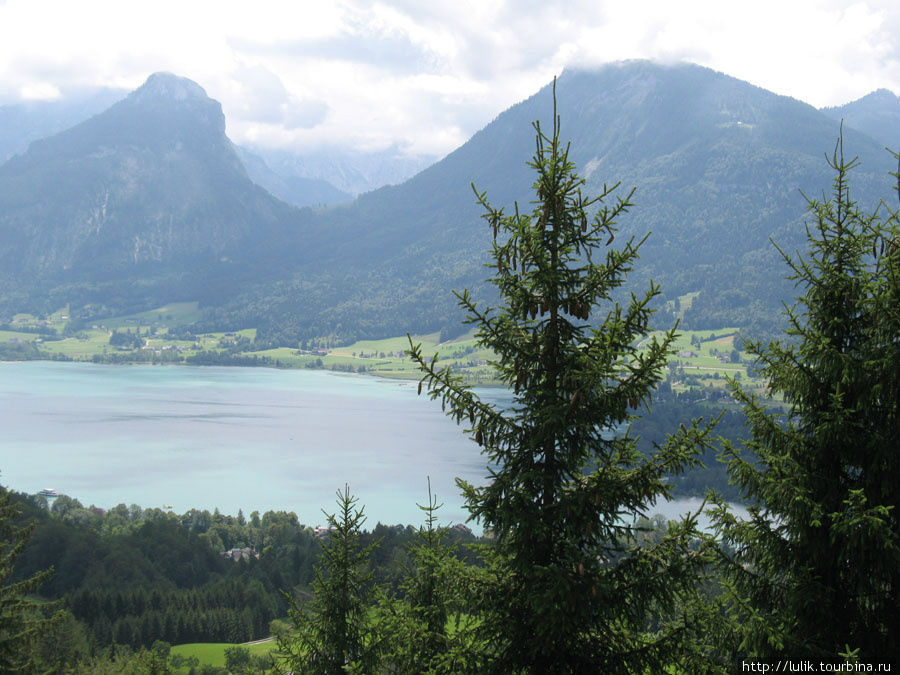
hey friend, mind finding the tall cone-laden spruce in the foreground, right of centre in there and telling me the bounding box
[410,80,709,673]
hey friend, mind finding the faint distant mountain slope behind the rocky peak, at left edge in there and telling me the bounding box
[0,88,128,164]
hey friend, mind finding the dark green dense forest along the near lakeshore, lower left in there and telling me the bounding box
[4,490,475,669]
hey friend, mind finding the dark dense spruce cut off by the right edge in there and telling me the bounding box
[718,138,900,662]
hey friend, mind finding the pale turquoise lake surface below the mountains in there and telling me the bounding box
[0,361,740,531]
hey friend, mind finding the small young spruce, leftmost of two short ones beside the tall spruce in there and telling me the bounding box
[278,486,378,675]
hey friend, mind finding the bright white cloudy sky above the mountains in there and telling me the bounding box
[0,0,900,155]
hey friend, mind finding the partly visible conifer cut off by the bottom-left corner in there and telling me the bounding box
[0,487,62,673]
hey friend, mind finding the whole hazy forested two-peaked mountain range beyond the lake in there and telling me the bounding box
[0,61,895,345]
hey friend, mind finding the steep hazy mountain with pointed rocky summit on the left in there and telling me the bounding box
[0,73,303,316]
